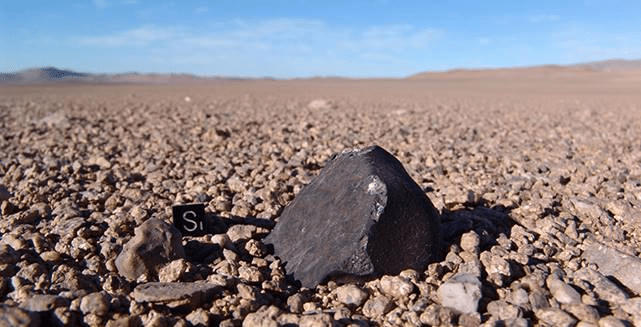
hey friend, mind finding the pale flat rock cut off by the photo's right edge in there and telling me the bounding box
[583,242,641,295]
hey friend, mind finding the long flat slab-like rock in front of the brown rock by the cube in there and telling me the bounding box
[131,282,222,308]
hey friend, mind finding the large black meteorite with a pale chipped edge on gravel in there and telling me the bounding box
[265,146,440,287]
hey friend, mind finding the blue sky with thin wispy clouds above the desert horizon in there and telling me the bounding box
[0,0,641,77]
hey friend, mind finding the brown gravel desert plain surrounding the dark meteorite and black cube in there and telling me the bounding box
[0,74,641,327]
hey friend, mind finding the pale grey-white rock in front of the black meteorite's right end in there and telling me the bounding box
[438,273,481,313]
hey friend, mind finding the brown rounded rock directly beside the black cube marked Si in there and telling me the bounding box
[116,218,185,280]
